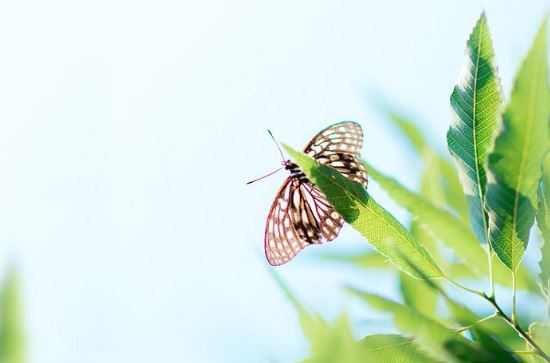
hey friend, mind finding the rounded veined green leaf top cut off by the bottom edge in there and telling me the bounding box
[358,334,443,363]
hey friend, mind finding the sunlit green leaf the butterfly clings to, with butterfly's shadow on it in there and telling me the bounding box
[284,145,443,278]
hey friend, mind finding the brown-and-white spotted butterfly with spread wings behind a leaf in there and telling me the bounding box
[264,121,368,266]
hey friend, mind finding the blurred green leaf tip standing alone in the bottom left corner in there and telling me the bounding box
[0,271,25,363]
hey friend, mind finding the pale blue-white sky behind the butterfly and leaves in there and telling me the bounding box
[0,0,548,363]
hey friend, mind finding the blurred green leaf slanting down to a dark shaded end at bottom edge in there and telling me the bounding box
[351,289,495,363]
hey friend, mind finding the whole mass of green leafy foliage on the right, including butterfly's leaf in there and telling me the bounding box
[270,14,550,363]
